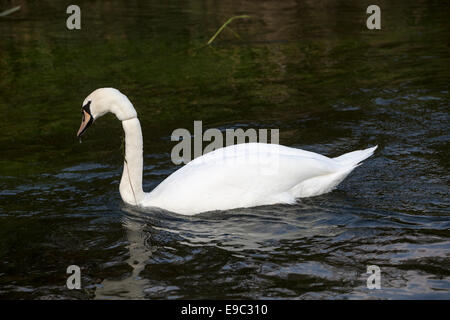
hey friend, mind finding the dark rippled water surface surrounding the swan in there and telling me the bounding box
[0,0,450,299]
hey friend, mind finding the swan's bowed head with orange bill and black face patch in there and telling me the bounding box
[77,88,137,138]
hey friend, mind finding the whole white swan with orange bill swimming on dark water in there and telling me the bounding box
[77,88,377,215]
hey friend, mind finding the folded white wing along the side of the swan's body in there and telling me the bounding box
[144,148,336,212]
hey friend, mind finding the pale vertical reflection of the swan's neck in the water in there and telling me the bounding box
[95,208,152,300]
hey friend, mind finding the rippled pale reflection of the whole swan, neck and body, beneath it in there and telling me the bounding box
[95,203,336,299]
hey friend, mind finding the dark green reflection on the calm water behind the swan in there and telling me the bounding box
[0,1,449,176]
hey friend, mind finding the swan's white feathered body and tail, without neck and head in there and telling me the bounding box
[142,143,376,214]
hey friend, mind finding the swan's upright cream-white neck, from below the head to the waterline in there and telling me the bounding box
[119,117,144,205]
